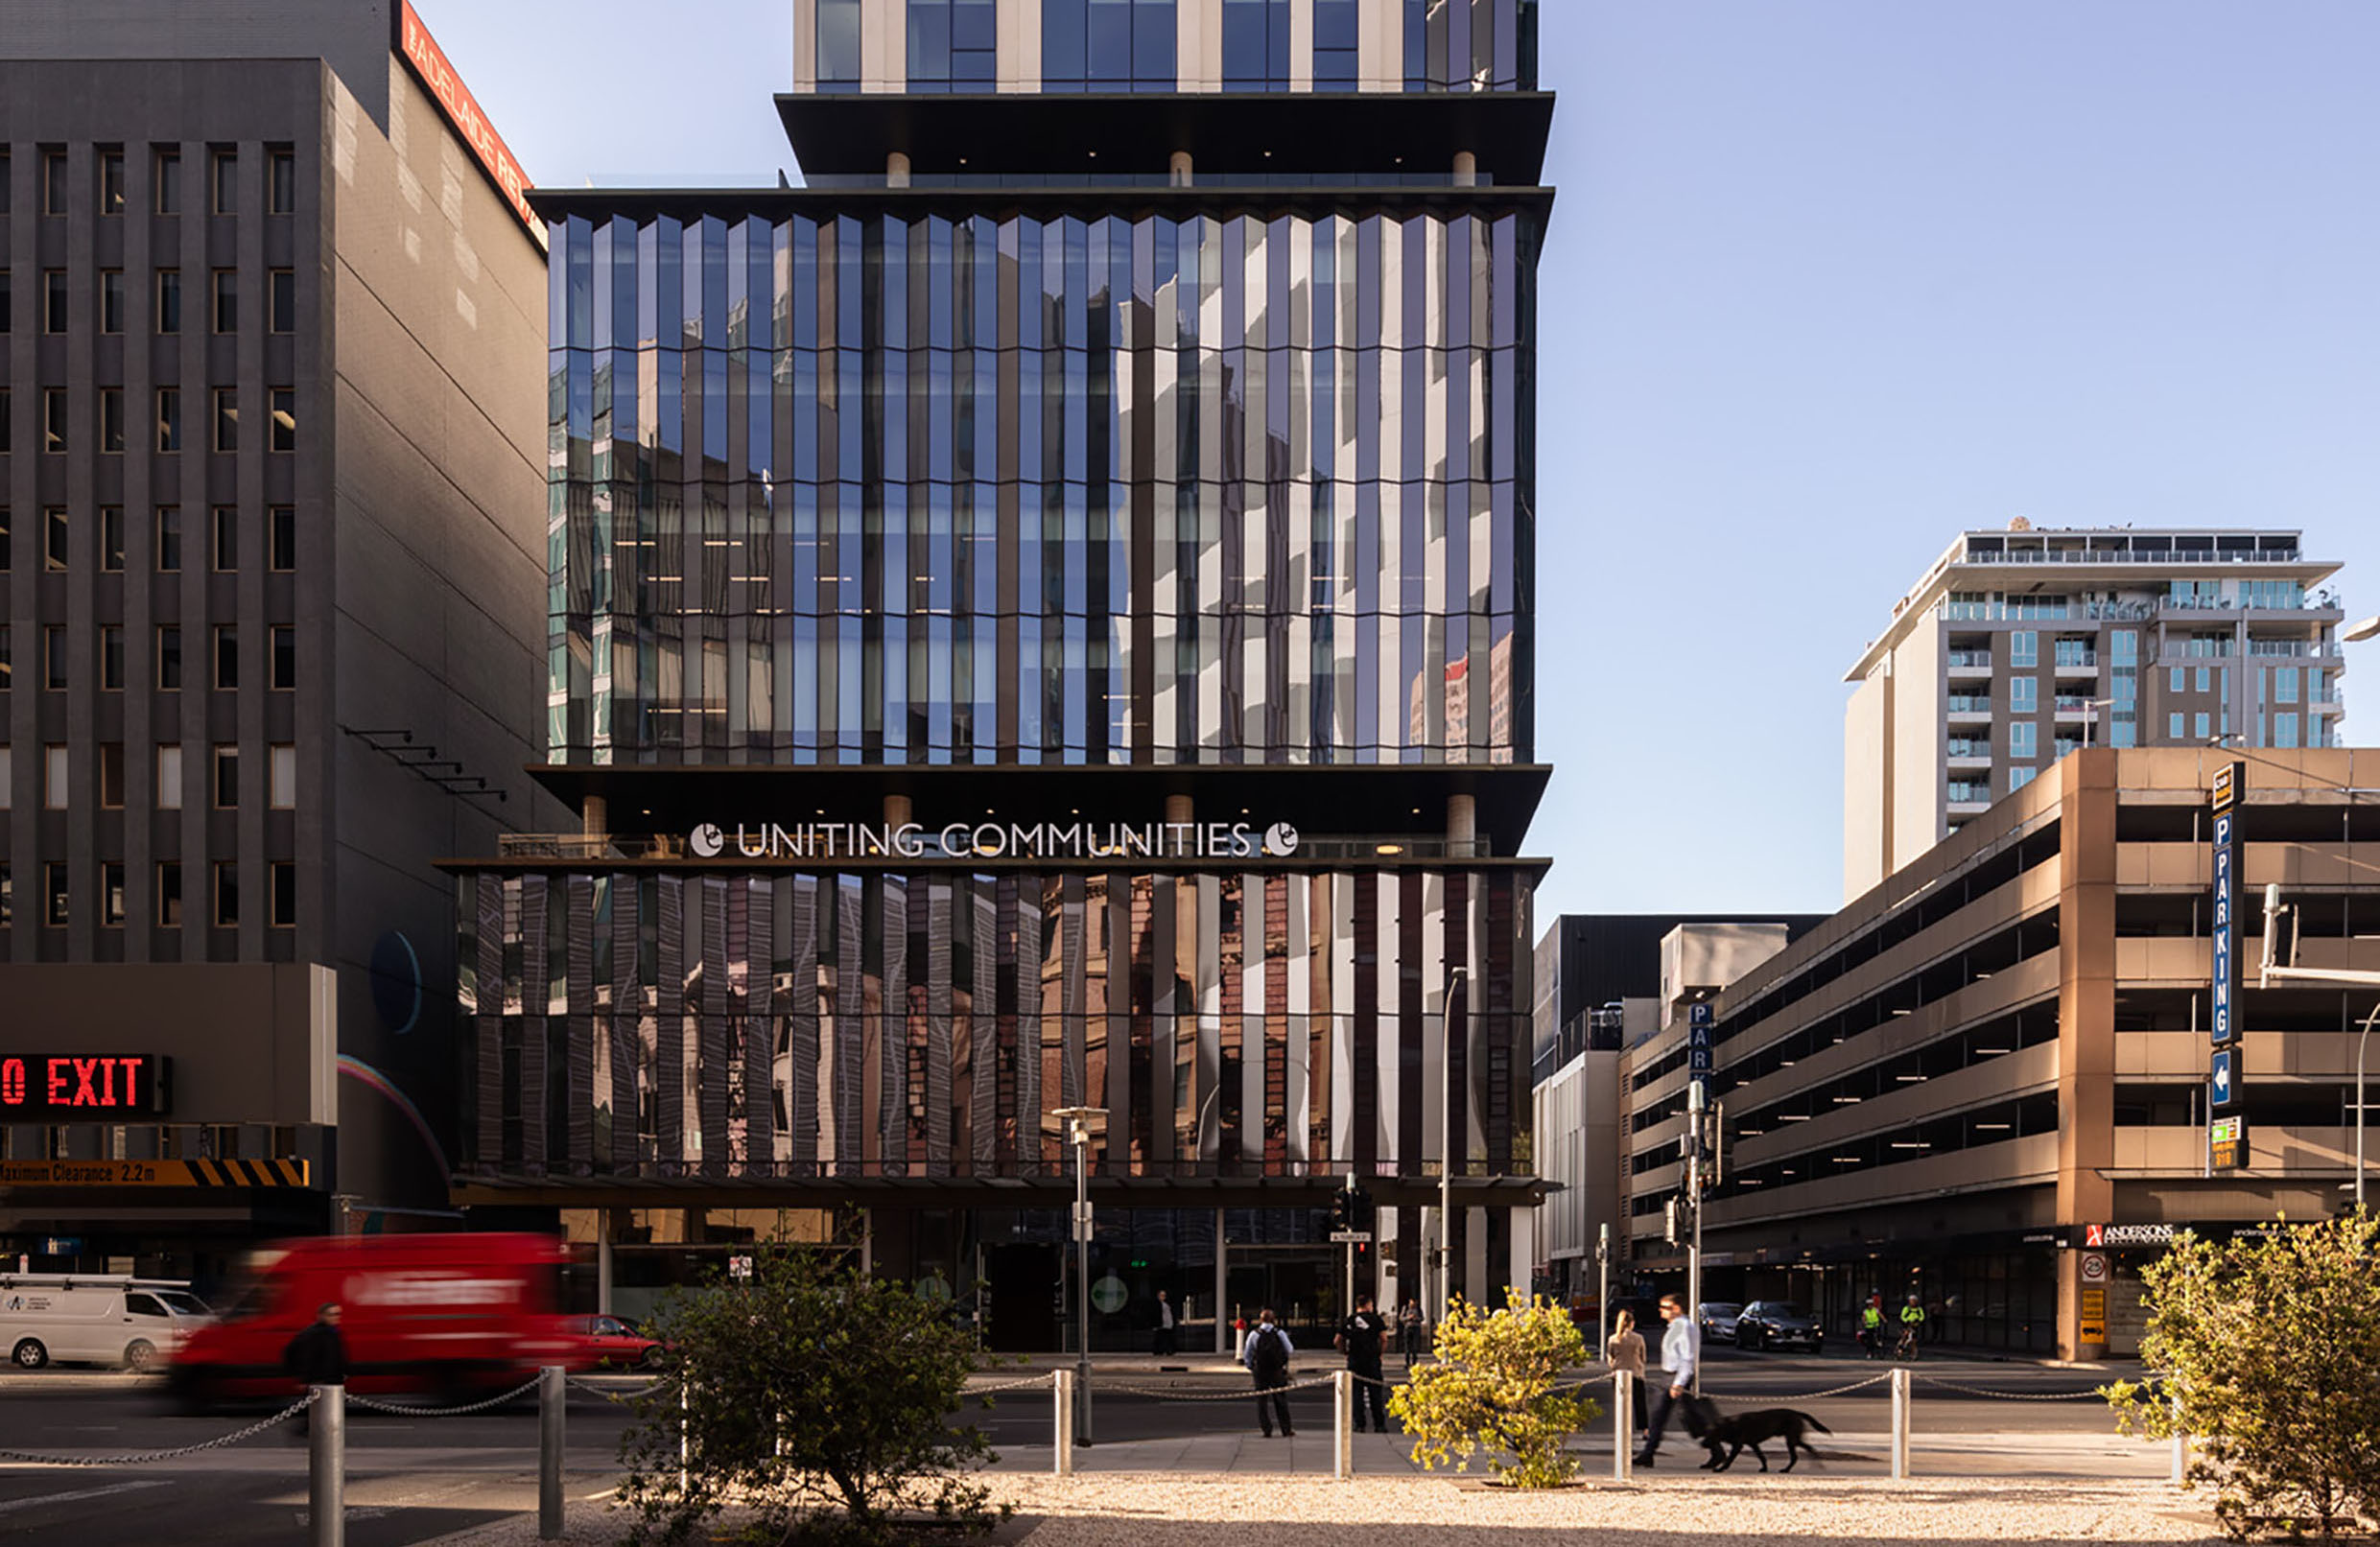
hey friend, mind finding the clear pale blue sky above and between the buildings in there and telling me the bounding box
[414,0,2380,926]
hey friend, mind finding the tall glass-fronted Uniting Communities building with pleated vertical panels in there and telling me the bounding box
[452,0,1552,1348]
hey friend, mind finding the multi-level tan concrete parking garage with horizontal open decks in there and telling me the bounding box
[1621,747,2380,1356]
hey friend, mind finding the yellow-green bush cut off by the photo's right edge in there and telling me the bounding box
[2102,1209,2380,1542]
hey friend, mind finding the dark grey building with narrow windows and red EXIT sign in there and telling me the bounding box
[0,0,545,1274]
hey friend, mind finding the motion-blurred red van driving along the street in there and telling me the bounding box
[167,1232,590,1407]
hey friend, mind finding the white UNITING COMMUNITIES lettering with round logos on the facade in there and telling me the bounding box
[686,821,1297,859]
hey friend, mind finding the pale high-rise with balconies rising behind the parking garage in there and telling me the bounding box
[1842,519,2345,902]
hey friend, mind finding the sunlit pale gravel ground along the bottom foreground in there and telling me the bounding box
[423,1473,2223,1547]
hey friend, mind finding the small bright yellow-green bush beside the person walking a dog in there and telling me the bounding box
[1387,1290,1602,1488]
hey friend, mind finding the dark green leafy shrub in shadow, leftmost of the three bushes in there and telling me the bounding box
[619,1250,1006,1545]
